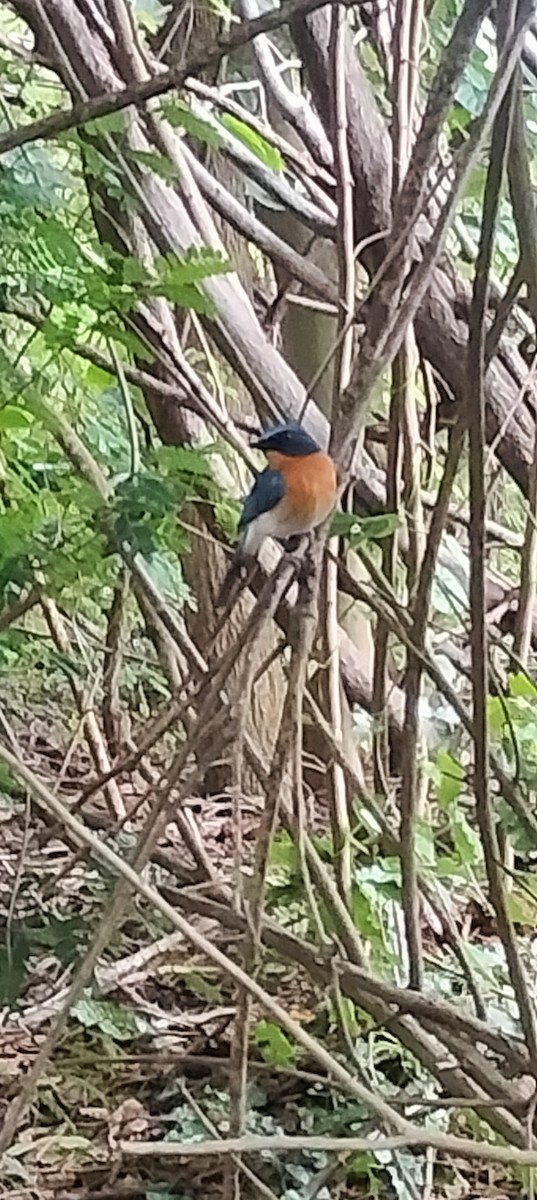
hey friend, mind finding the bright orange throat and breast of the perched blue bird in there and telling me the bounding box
[267,451,337,527]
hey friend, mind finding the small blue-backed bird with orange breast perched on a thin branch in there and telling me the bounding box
[235,421,338,563]
